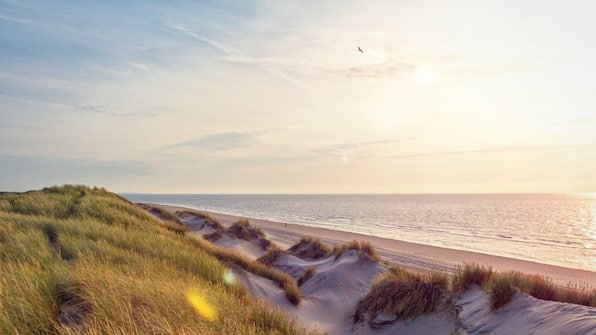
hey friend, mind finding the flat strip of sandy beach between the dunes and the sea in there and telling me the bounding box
[153,204,596,288]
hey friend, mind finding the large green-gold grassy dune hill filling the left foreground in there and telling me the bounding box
[0,186,318,334]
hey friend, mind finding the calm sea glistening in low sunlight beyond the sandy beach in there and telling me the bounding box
[123,194,596,275]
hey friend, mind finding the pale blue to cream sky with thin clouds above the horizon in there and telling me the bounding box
[0,0,596,193]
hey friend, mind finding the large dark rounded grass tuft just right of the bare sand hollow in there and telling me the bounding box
[353,272,447,329]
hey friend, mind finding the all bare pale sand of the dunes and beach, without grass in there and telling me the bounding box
[151,206,596,335]
